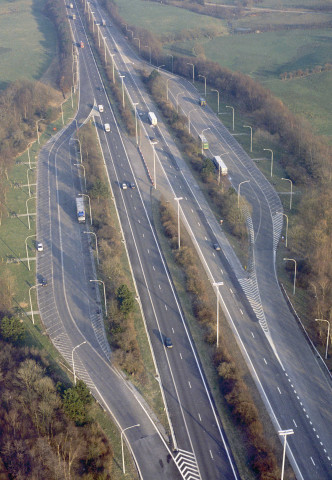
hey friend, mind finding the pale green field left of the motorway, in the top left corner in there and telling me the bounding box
[0,0,56,89]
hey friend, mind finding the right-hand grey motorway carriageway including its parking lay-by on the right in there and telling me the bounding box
[86,3,332,479]
